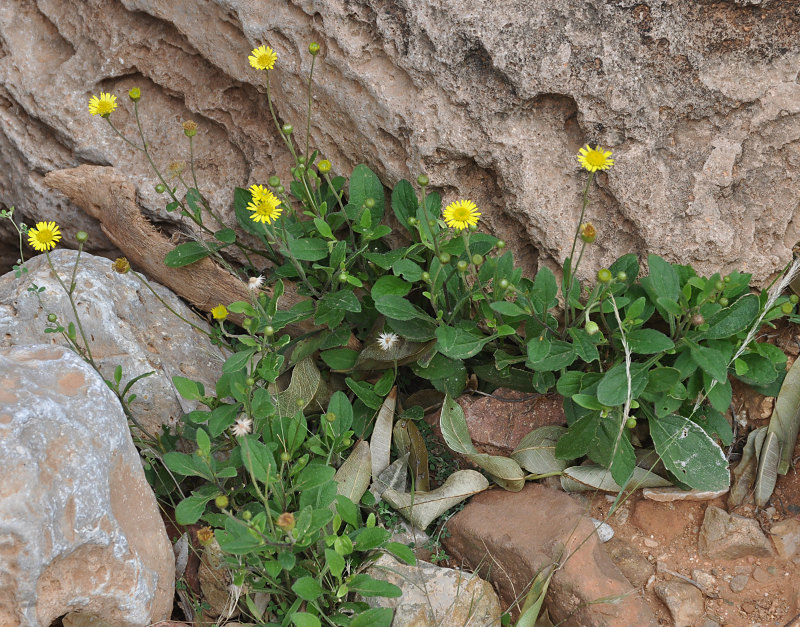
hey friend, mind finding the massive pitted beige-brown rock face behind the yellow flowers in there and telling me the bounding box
[0,0,800,281]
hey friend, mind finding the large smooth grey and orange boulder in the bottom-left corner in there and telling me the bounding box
[0,345,175,627]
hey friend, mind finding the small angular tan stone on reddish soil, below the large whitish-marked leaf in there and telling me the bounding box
[697,505,772,559]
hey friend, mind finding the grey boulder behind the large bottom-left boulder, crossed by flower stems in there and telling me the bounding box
[0,249,224,433]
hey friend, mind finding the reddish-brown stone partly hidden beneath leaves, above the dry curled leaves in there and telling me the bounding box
[426,388,567,457]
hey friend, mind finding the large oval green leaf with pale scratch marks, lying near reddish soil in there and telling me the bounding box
[649,414,730,491]
